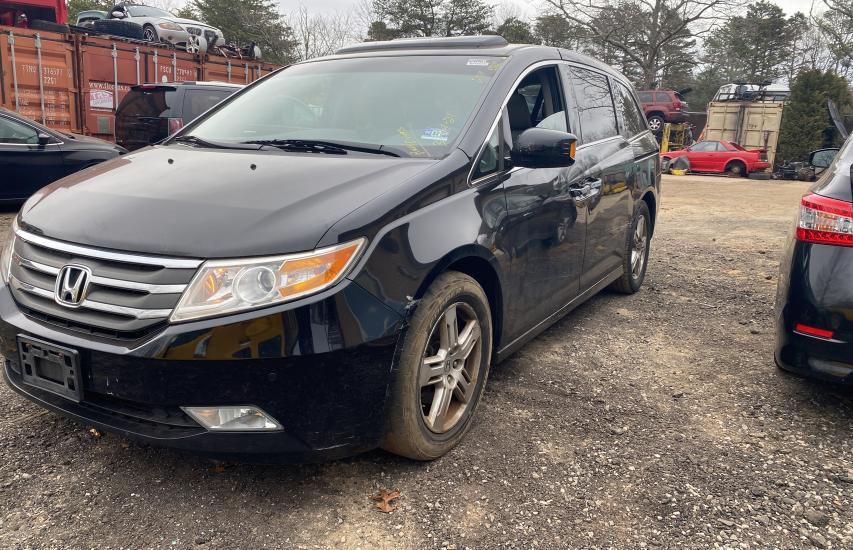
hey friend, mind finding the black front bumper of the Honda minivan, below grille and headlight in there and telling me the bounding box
[0,281,402,462]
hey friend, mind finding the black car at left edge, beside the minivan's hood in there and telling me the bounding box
[0,107,127,201]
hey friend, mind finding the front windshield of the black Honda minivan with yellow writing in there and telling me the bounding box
[183,56,503,158]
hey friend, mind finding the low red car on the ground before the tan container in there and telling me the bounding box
[660,140,770,176]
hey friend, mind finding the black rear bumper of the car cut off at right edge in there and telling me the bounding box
[774,239,853,384]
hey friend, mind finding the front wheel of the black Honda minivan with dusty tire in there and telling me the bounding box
[382,271,492,460]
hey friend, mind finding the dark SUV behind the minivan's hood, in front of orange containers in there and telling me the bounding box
[116,82,243,151]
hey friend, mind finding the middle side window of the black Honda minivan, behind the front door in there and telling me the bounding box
[571,66,619,143]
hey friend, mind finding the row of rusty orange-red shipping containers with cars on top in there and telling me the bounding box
[0,23,278,141]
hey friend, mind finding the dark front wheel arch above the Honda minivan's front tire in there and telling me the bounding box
[415,245,504,350]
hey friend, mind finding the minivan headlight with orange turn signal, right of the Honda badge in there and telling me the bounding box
[170,239,365,322]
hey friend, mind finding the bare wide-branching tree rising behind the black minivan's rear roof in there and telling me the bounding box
[545,0,743,85]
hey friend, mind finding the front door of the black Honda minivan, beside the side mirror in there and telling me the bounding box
[504,65,591,328]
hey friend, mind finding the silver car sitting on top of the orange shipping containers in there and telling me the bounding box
[109,4,225,52]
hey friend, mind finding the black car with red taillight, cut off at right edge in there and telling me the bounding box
[775,135,853,384]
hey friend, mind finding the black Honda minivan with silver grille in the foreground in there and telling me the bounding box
[0,36,659,462]
